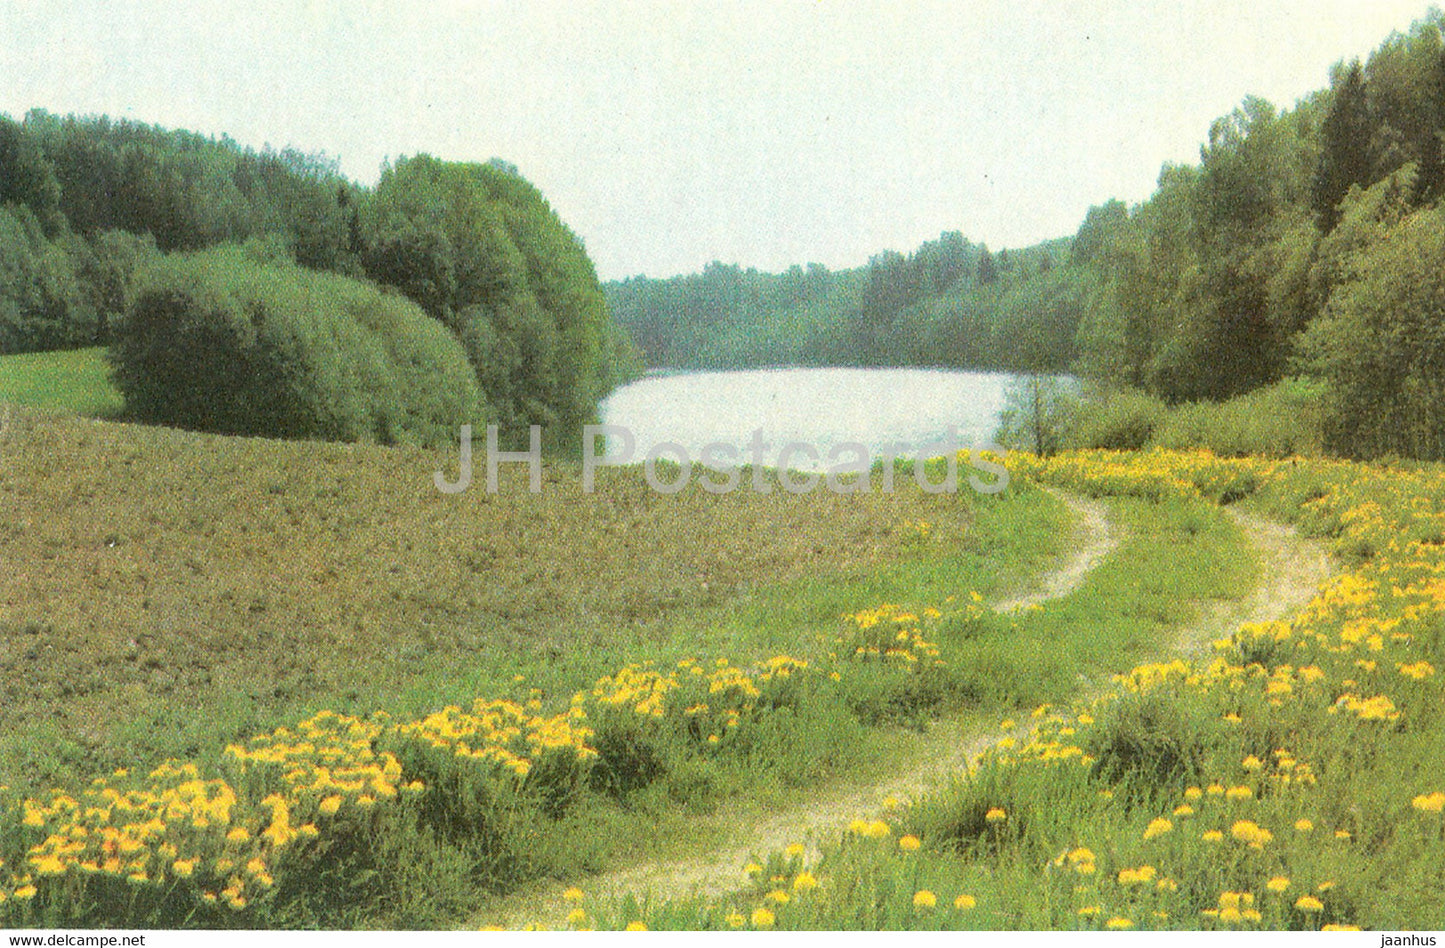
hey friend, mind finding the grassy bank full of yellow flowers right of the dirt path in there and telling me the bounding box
[578,452,1445,931]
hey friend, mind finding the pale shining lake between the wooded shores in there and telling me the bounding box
[601,369,1014,470]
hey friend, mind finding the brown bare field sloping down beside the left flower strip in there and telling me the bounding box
[0,409,1005,786]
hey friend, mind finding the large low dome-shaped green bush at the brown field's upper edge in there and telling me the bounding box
[110,247,484,445]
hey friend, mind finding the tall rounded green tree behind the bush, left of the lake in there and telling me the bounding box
[361,155,611,442]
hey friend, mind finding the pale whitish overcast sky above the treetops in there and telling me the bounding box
[0,0,1429,279]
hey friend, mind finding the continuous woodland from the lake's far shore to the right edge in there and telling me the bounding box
[605,10,1445,460]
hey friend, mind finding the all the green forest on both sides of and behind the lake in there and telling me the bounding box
[8,10,1445,460]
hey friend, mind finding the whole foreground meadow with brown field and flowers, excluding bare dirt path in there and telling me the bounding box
[11,343,1445,929]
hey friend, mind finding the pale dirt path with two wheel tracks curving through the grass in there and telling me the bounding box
[488,491,1332,928]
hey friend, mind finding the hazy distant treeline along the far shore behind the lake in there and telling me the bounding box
[604,233,1088,371]
